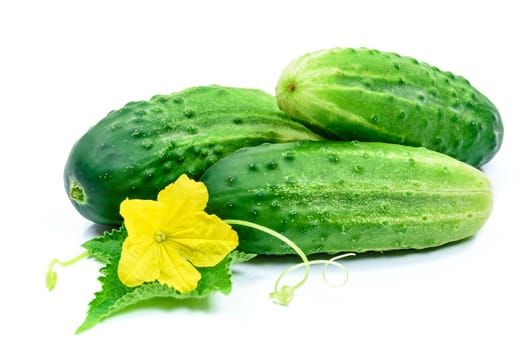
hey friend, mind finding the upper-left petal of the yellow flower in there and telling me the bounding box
[120,199,168,237]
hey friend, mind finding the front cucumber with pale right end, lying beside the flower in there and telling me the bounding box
[201,141,492,255]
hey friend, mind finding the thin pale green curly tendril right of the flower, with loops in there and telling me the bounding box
[224,219,355,305]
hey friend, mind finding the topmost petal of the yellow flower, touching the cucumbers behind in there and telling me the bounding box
[158,174,208,218]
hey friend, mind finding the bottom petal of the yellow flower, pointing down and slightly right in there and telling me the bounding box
[158,246,202,293]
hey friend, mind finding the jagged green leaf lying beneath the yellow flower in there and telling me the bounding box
[76,227,233,334]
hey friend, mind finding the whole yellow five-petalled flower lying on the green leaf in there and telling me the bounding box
[118,175,238,293]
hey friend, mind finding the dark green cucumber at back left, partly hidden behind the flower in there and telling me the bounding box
[64,85,321,225]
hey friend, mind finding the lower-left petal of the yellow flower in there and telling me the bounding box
[118,236,160,287]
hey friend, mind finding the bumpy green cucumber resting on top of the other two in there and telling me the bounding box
[276,48,503,167]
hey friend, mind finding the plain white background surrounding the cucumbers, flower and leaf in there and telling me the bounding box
[0,0,524,349]
